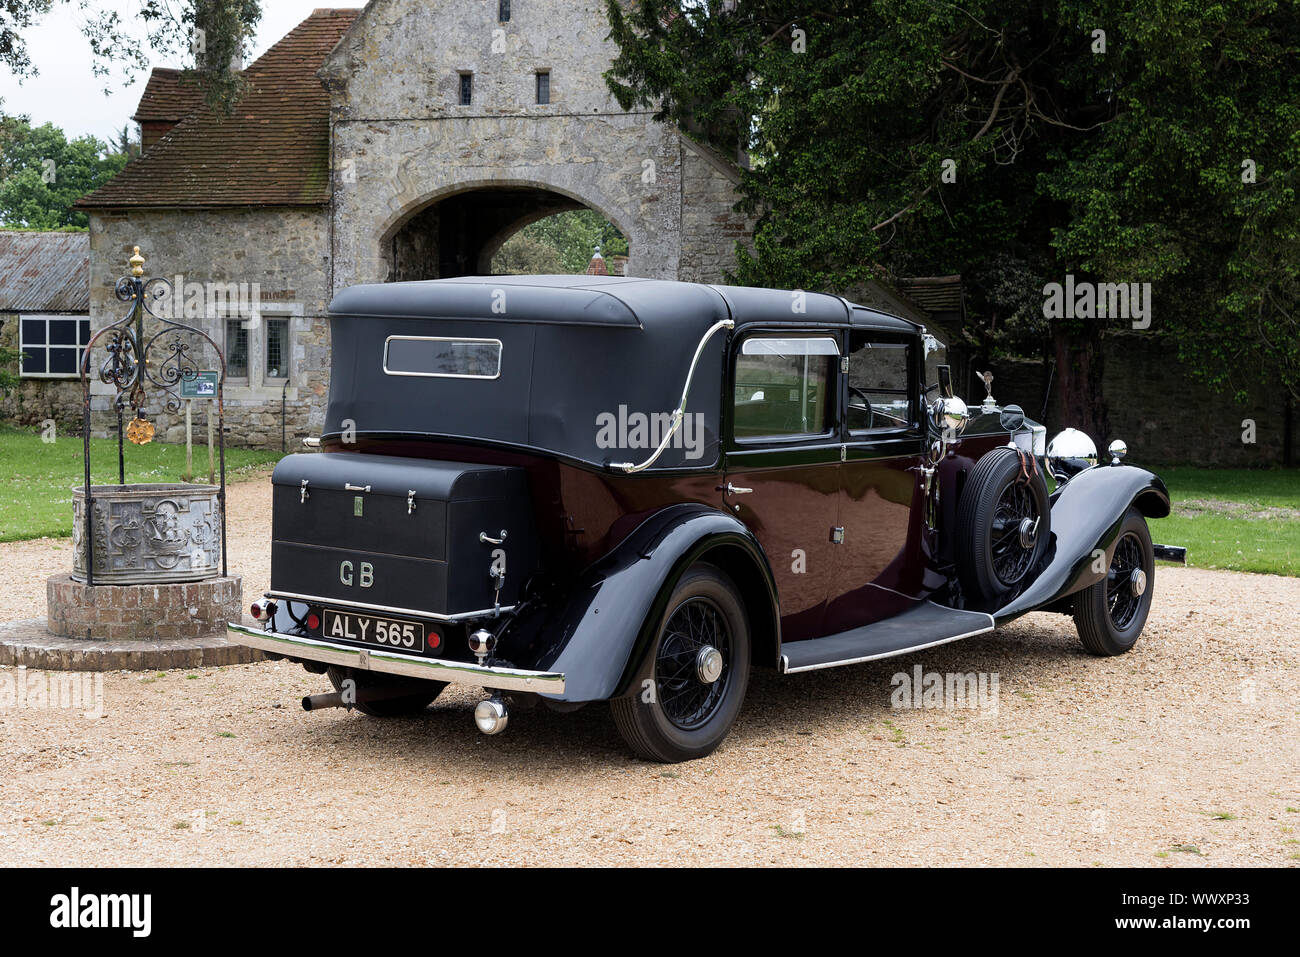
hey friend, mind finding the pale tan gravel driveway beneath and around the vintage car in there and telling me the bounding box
[0,481,1300,867]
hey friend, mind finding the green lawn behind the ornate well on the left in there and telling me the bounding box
[0,426,280,542]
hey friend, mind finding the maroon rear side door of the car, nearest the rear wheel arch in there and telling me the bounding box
[723,330,842,641]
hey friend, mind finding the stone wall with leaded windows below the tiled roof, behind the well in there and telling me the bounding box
[90,208,330,449]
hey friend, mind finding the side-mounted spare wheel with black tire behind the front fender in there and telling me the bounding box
[956,447,1052,603]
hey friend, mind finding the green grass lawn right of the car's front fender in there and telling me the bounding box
[1151,467,1300,576]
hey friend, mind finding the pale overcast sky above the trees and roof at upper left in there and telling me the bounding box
[0,0,365,140]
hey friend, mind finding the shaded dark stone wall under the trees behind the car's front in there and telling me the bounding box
[958,333,1300,468]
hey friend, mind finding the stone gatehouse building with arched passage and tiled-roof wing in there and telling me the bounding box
[71,0,924,446]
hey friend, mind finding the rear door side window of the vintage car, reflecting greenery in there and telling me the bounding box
[732,335,840,441]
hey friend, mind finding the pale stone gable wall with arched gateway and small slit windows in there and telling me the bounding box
[320,0,696,290]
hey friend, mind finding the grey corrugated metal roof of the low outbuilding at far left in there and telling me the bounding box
[0,230,90,312]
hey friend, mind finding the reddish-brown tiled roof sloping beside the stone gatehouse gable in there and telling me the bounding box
[77,9,360,209]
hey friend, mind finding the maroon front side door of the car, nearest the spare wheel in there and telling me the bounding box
[826,329,933,633]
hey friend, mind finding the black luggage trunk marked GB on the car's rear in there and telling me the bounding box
[270,452,537,616]
